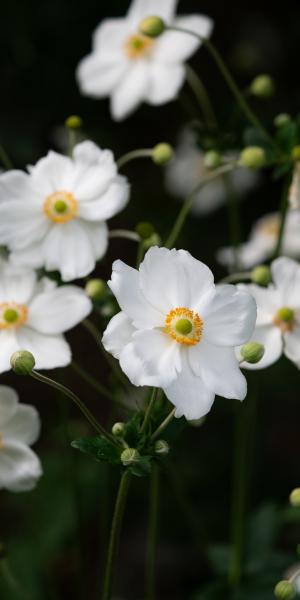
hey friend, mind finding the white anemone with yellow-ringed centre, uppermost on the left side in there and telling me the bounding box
[0,141,129,281]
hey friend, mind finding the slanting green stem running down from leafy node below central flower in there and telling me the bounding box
[102,471,131,600]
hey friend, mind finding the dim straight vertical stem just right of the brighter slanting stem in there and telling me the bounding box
[146,464,159,600]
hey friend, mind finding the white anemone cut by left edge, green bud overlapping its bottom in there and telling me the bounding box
[0,260,92,373]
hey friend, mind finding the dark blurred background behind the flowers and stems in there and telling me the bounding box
[0,0,300,600]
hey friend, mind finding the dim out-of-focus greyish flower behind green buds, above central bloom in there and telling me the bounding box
[166,130,258,215]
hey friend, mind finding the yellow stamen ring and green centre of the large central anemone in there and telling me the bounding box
[165,307,203,346]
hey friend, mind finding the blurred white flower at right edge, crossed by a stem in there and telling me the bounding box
[217,210,300,269]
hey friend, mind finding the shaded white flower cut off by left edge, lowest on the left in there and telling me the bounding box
[0,385,42,492]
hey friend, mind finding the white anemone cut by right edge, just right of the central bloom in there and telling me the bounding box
[239,257,300,370]
